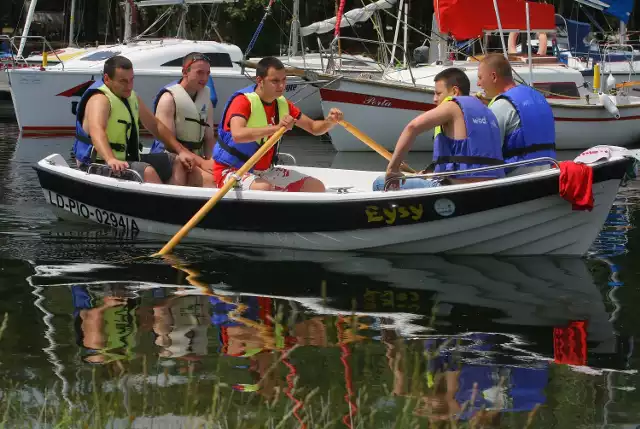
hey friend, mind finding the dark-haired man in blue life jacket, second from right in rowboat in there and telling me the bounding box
[373,68,504,191]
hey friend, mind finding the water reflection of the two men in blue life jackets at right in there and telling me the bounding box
[382,334,548,427]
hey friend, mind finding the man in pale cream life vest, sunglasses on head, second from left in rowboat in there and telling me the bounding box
[151,52,216,187]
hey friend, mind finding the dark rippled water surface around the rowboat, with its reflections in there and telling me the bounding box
[0,124,640,428]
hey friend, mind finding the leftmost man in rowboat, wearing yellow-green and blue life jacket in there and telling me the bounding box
[73,55,196,185]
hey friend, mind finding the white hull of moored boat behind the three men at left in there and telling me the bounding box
[7,69,322,137]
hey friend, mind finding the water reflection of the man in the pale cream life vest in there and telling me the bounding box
[153,295,209,360]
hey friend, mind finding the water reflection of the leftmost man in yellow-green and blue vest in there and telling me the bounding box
[71,285,138,364]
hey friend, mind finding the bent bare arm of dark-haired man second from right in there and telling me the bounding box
[387,103,458,172]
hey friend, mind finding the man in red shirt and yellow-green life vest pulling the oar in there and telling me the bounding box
[213,57,343,192]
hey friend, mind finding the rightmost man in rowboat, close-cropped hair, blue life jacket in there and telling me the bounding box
[478,54,556,176]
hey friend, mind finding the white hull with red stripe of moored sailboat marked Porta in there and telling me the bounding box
[320,79,640,152]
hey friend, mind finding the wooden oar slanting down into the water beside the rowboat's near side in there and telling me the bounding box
[153,127,287,256]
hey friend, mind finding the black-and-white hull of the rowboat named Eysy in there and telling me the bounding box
[36,155,631,256]
